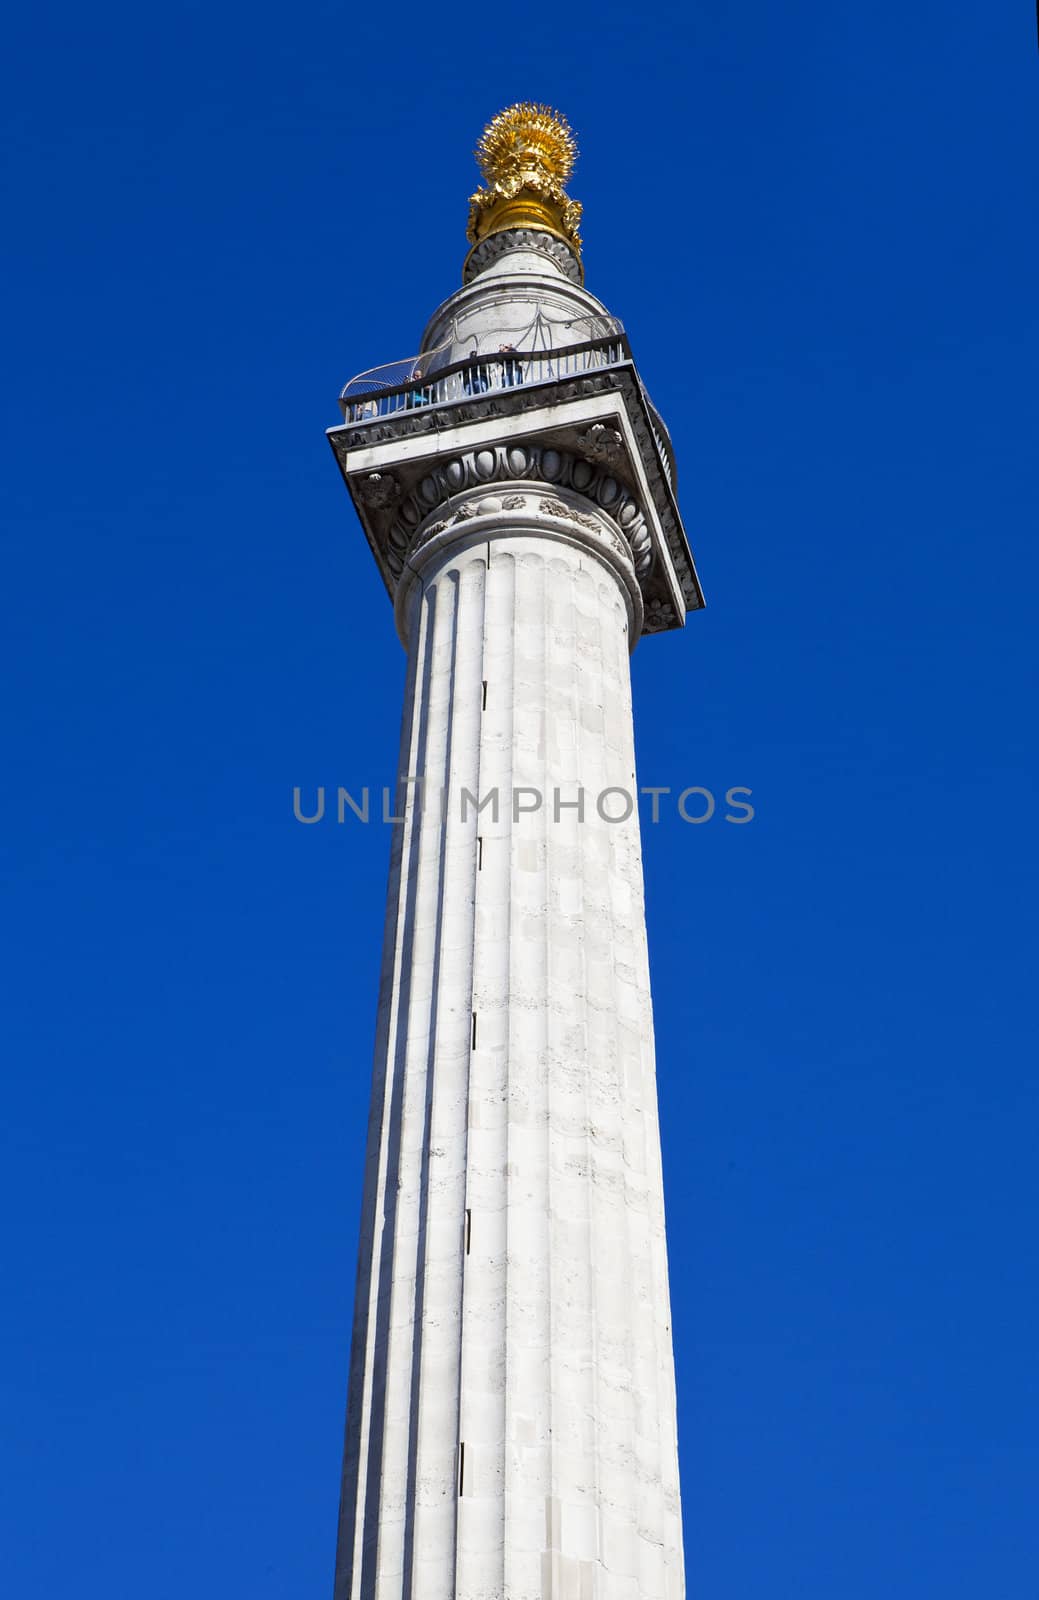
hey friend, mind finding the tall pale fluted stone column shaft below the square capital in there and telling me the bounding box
[336,478,684,1600]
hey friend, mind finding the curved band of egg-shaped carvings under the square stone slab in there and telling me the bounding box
[387,444,653,579]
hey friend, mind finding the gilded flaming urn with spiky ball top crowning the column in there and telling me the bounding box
[467,101,581,251]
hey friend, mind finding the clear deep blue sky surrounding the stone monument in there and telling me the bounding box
[0,0,1039,1600]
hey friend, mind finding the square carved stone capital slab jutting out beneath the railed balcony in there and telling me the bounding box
[328,353,703,637]
